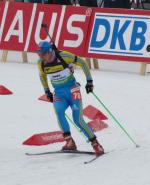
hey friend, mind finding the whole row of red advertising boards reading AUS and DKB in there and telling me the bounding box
[0,1,150,73]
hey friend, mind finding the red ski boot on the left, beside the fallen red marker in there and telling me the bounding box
[62,133,77,150]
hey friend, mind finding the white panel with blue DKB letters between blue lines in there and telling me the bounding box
[89,13,149,56]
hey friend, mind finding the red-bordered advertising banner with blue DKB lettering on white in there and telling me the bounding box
[86,9,150,61]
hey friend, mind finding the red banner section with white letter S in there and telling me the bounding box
[58,6,92,56]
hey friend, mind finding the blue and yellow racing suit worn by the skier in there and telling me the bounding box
[38,51,95,140]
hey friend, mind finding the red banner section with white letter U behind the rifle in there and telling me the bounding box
[27,4,62,51]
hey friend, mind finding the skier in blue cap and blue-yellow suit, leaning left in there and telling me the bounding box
[37,41,104,156]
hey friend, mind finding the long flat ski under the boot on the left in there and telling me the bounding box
[25,150,95,156]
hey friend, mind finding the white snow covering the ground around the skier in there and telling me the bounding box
[0,55,150,185]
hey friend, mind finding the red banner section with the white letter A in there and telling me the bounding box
[0,2,33,51]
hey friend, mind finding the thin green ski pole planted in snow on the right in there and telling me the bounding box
[92,92,139,147]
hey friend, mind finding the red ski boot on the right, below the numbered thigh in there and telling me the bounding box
[91,138,104,156]
